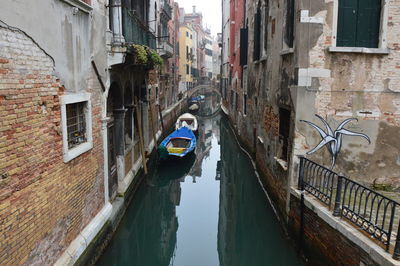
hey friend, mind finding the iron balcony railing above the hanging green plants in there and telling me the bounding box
[122,7,157,49]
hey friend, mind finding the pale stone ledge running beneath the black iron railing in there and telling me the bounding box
[290,187,400,266]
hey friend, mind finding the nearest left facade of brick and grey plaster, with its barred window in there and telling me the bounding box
[0,1,106,265]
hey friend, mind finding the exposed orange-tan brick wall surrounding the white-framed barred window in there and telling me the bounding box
[0,22,104,265]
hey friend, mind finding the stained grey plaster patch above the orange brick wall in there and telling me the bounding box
[0,0,95,92]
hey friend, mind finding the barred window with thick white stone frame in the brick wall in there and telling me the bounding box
[61,93,93,162]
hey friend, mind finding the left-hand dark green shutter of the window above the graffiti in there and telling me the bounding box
[336,0,358,47]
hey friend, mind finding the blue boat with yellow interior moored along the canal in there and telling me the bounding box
[158,127,197,160]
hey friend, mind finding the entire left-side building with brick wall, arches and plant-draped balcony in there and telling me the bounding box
[0,0,177,265]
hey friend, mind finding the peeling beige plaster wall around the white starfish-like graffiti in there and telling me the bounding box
[295,1,400,184]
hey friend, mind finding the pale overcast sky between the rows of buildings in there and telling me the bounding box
[175,0,222,36]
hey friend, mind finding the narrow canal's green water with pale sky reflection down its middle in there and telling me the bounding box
[97,92,301,266]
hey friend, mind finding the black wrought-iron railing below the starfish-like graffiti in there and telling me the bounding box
[298,157,400,260]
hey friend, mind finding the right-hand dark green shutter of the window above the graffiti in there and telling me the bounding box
[356,0,381,48]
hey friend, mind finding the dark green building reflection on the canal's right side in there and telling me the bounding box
[218,122,299,266]
